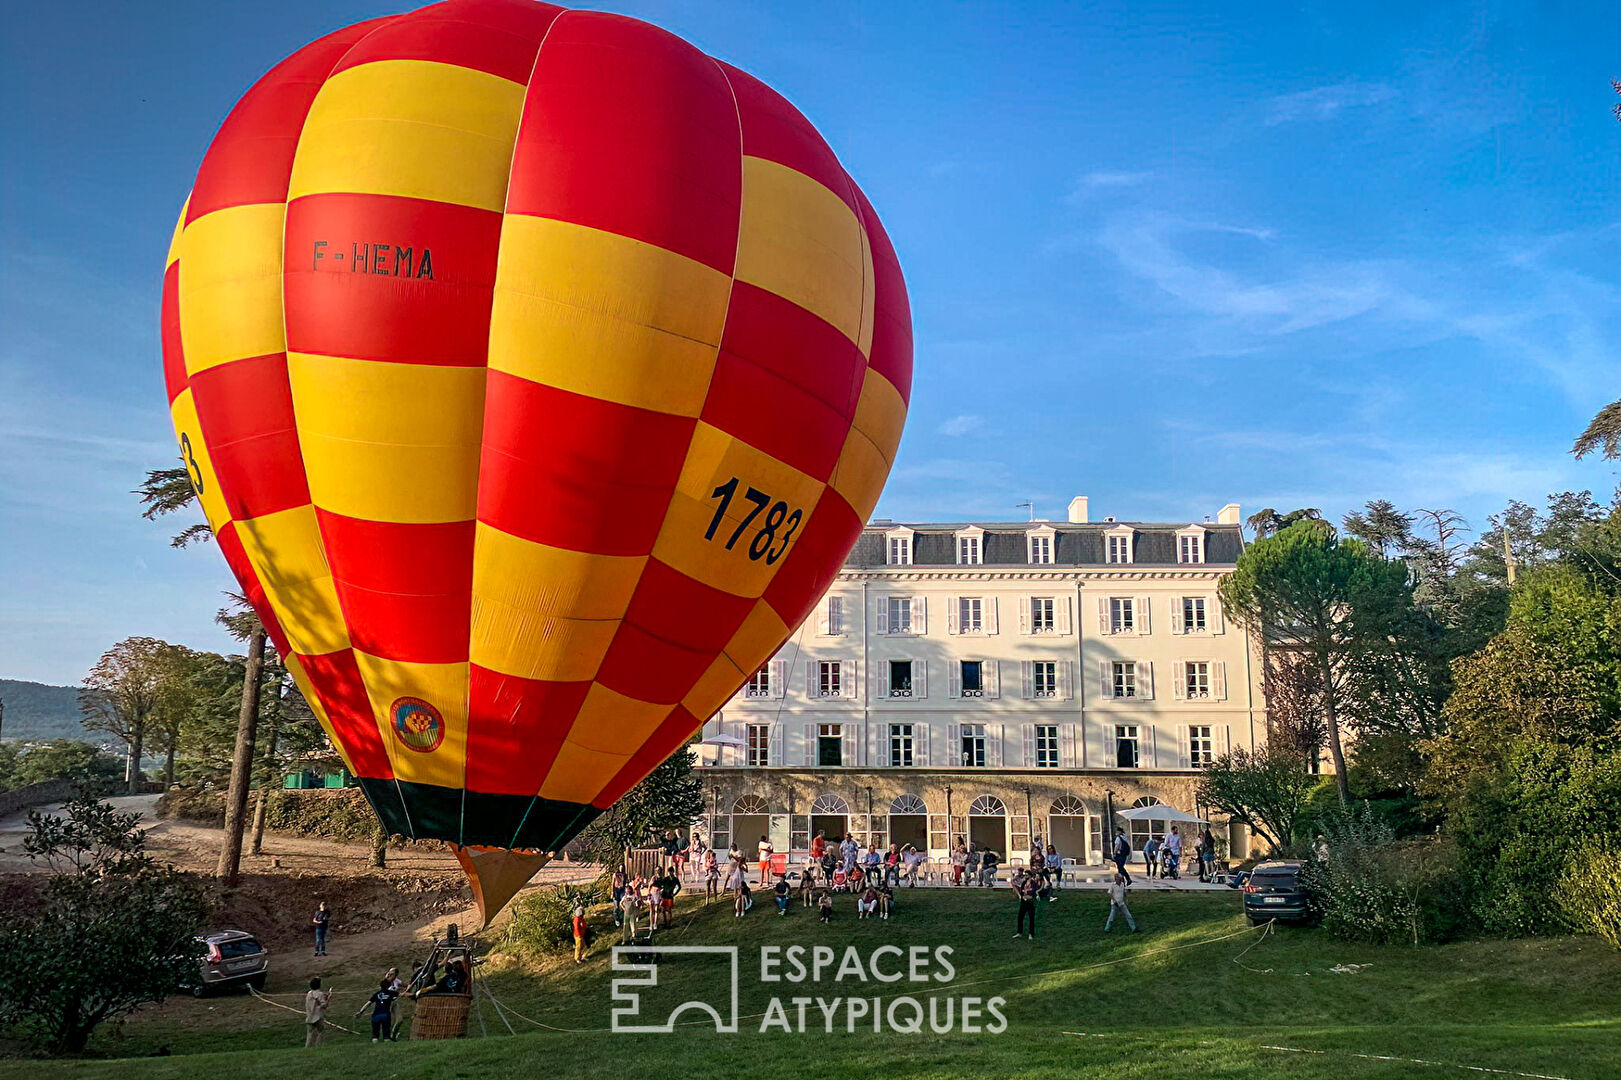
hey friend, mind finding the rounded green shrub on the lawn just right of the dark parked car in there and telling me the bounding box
[1307,804,1464,945]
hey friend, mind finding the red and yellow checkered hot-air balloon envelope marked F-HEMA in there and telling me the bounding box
[162,0,911,919]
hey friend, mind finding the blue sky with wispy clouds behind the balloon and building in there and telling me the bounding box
[0,0,1621,683]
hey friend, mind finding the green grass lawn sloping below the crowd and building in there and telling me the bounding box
[0,890,1621,1080]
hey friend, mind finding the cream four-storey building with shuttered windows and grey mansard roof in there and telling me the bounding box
[699,496,1266,863]
